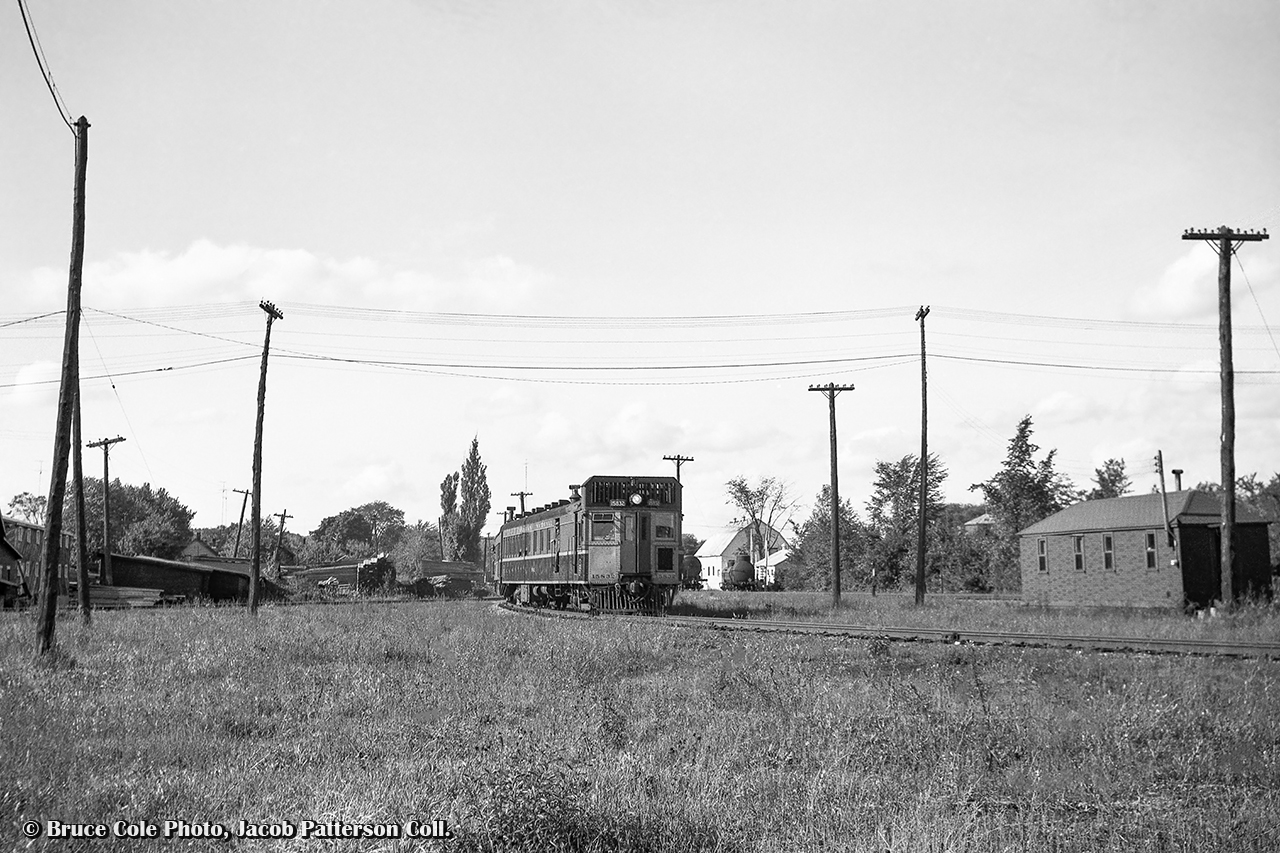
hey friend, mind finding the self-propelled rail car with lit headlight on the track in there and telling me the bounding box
[494,476,681,613]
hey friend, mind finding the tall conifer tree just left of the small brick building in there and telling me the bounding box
[969,415,1079,589]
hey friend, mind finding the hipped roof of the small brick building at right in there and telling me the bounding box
[1019,489,1270,537]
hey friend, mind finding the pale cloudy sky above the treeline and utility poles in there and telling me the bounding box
[0,0,1280,538]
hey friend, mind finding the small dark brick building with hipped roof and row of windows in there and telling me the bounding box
[1019,489,1271,608]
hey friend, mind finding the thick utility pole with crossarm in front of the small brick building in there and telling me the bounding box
[1183,225,1268,607]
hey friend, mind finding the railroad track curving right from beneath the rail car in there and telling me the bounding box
[502,596,1280,661]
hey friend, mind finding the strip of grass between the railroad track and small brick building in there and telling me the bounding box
[673,590,1280,642]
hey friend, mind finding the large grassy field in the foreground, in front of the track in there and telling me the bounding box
[0,602,1280,852]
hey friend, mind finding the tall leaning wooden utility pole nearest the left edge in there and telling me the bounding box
[36,115,88,657]
